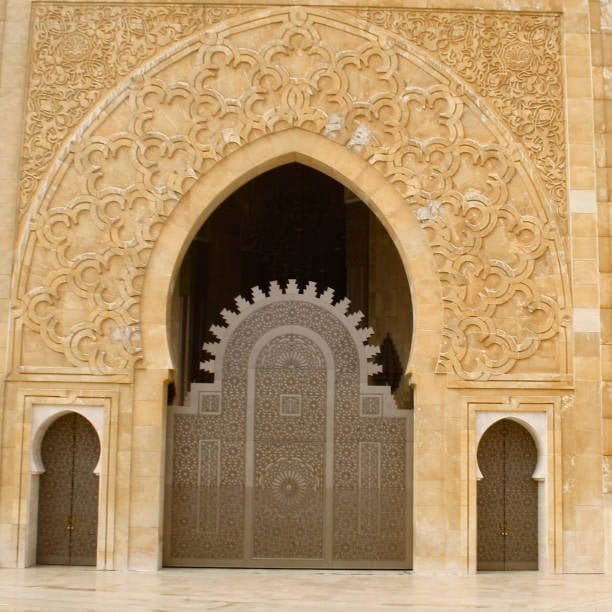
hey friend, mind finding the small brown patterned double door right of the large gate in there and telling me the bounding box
[477,419,538,570]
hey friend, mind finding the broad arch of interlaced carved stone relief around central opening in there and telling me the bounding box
[13,8,569,381]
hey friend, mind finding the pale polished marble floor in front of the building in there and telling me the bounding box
[0,567,612,612]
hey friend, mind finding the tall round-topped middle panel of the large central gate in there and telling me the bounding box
[252,330,331,559]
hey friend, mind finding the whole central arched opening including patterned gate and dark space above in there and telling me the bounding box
[164,164,412,568]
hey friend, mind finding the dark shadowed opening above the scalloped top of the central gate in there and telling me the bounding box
[171,163,413,407]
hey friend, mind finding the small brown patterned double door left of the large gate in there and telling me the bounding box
[36,413,100,565]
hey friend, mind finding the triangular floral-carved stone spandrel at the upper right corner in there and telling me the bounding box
[354,9,567,221]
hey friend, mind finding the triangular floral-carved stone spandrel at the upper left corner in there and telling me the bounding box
[21,2,248,208]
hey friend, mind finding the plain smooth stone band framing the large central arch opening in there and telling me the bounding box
[141,129,443,384]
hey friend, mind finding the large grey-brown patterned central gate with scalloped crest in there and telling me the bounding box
[164,282,409,568]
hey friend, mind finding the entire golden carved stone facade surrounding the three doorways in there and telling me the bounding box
[0,0,612,572]
